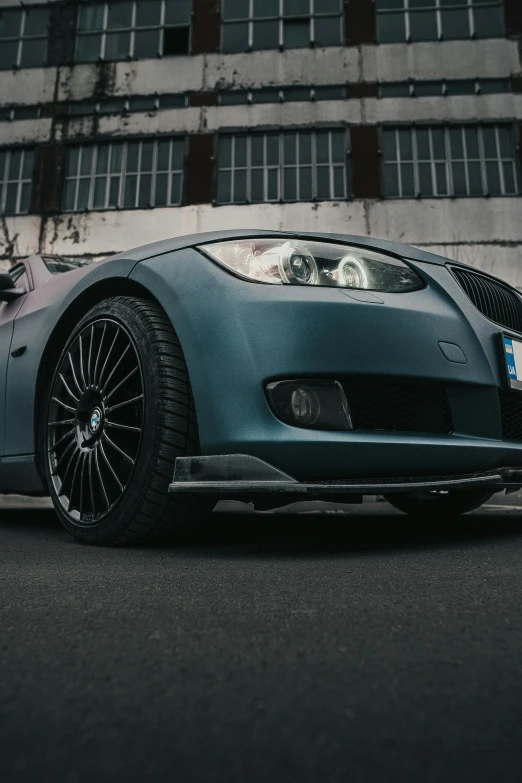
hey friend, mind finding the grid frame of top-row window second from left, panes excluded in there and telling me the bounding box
[74,0,193,63]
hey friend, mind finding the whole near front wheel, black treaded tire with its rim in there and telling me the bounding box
[41,296,213,546]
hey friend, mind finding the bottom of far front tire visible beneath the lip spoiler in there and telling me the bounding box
[384,489,494,516]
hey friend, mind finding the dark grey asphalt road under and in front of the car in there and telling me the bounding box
[0,500,522,783]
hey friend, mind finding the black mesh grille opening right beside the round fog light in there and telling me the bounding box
[344,378,453,435]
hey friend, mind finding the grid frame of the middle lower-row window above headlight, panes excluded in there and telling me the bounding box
[212,124,353,206]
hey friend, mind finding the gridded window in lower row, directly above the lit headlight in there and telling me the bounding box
[217,129,347,204]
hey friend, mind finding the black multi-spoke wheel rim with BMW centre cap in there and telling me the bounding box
[47,318,145,525]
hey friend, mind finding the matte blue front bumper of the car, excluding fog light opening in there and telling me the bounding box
[132,250,522,484]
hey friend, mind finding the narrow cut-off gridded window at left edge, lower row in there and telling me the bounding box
[0,149,34,215]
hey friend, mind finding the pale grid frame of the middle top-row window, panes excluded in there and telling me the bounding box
[220,0,346,54]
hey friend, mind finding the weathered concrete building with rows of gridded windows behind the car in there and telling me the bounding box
[0,0,522,288]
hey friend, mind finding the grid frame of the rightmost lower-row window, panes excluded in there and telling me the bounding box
[378,121,522,201]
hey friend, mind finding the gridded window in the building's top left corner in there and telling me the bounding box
[0,7,49,69]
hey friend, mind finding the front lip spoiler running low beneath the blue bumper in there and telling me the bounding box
[169,454,512,496]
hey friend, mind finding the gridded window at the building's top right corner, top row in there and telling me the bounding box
[375,0,504,43]
